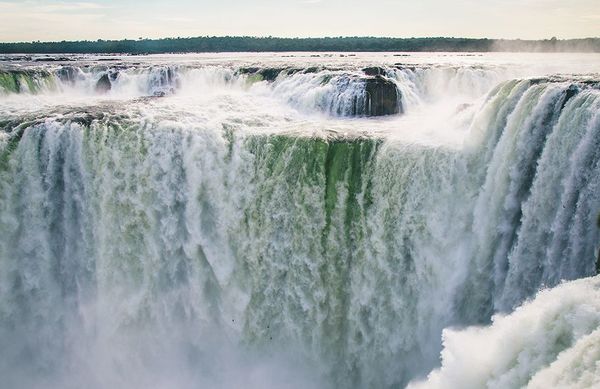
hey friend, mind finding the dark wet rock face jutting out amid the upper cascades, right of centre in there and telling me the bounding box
[365,76,402,116]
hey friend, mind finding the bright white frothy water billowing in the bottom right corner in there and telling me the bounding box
[408,277,600,389]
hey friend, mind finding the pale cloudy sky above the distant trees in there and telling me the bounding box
[0,0,600,42]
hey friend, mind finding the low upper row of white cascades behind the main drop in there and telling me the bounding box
[0,64,507,117]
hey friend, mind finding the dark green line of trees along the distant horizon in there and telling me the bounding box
[0,36,600,54]
